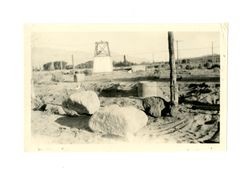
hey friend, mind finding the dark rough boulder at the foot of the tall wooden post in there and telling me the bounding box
[142,97,171,117]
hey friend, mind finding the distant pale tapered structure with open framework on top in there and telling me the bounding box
[93,41,113,73]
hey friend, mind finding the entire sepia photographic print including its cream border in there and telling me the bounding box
[24,24,227,151]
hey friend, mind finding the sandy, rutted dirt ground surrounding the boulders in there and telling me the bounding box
[31,70,220,144]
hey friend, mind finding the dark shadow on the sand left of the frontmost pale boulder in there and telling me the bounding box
[55,115,91,132]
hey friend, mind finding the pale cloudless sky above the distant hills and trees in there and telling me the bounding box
[31,32,220,64]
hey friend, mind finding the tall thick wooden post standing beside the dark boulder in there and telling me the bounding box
[168,32,178,106]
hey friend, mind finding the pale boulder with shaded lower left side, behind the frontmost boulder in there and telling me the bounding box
[62,91,100,116]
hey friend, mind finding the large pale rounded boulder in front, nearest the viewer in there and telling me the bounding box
[89,105,148,137]
